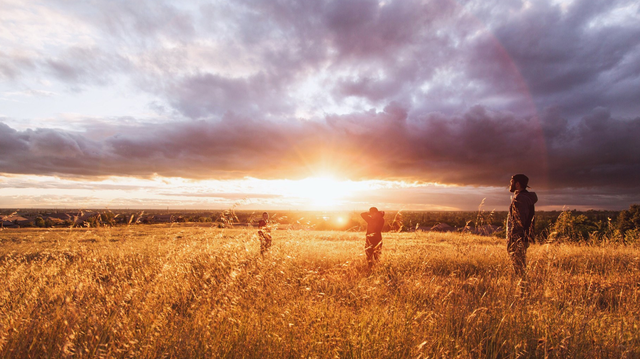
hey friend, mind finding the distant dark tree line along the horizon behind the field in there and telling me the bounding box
[0,204,640,243]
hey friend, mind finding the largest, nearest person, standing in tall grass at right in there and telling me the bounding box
[507,174,538,278]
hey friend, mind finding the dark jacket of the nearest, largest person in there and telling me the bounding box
[507,190,538,243]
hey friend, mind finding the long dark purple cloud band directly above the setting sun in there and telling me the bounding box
[0,103,640,188]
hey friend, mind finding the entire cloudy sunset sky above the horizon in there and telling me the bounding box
[0,0,640,210]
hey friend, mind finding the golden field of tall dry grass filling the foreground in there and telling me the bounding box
[0,226,640,358]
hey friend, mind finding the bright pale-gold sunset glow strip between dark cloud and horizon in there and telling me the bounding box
[0,175,632,211]
